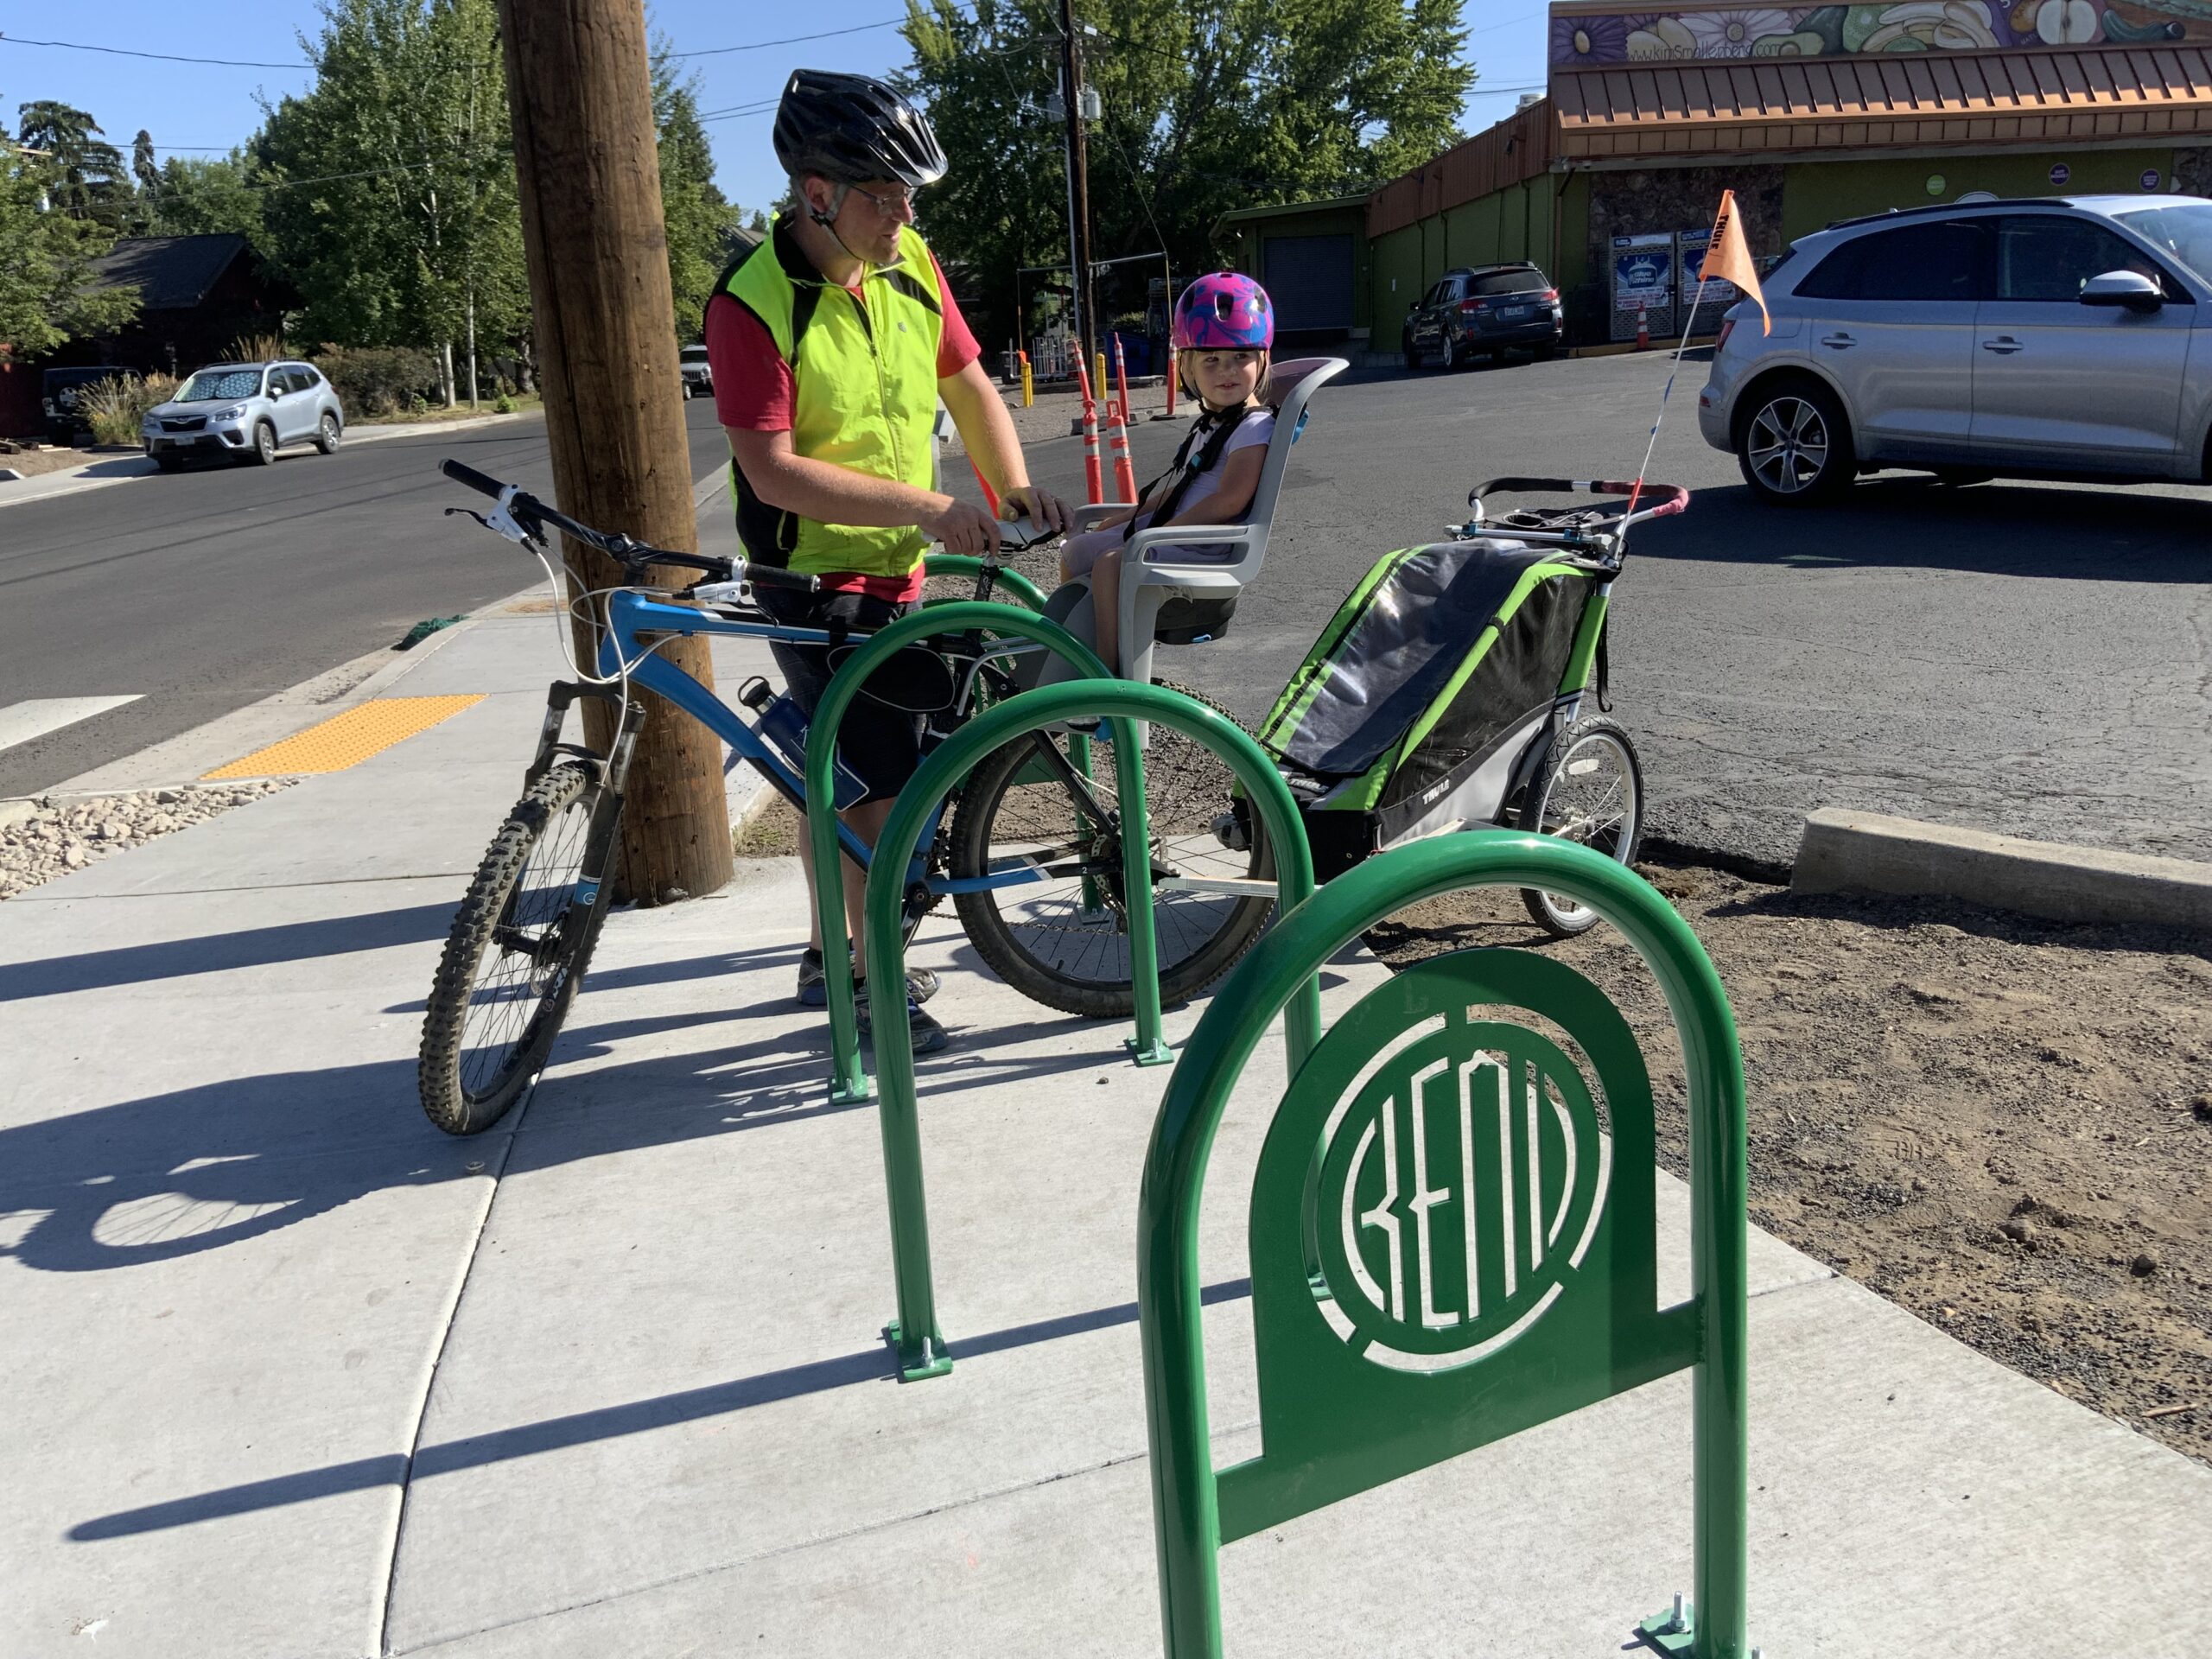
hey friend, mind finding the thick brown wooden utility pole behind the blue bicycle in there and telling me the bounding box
[500,0,732,905]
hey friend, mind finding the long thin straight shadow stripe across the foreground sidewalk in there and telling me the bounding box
[68,1279,1252,1544]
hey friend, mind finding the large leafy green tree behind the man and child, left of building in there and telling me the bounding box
[905,0,1476,342]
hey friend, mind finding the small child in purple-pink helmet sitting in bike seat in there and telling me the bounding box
[1059,270,1274,672]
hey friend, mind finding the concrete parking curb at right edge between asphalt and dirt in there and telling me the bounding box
[1789,807,2212,929]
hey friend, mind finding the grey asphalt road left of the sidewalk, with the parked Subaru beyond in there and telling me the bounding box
[0,400,728,798]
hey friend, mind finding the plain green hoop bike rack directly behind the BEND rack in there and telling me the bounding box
[868,681,1320,1382]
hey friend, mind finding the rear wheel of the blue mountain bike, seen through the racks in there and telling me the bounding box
[949,681,1274,1020]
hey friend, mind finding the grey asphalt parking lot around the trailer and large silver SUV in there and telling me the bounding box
[1000,354,2212,862]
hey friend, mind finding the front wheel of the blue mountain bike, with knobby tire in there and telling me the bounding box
[416,761,621,1135]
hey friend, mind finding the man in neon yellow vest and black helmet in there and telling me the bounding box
[706,68,1068,1053]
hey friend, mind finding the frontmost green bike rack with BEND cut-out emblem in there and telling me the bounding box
[1137,830,1747,1659]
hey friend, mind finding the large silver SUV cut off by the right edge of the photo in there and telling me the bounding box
[1697,194,2212,505]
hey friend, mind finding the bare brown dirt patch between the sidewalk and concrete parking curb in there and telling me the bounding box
[1370,868,2212,1462]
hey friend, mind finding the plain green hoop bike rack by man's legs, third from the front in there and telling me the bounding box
[805,606,1123,1106]
